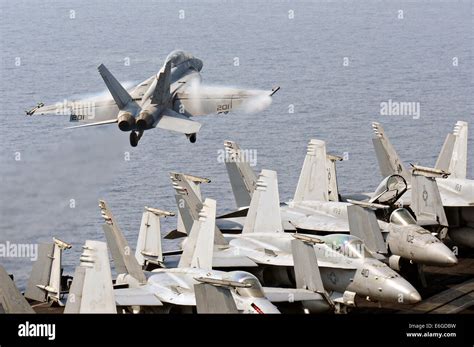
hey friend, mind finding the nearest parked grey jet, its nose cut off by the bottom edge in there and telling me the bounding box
[100,199,327,313]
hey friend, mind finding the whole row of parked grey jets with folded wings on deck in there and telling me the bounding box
[0,122,474,313]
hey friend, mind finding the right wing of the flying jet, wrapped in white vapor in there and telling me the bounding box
[173,85,278,116]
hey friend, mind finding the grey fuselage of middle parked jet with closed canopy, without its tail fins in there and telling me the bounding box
[219,232,420,303]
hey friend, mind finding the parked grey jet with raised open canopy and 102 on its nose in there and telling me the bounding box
[211,140,457,270]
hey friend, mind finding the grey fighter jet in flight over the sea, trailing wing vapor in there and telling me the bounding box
[26,50,279,147]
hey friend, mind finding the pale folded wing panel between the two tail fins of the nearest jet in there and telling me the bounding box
[135,207,174,270]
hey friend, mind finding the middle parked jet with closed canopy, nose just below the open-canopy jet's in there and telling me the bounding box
[172,170,421,306]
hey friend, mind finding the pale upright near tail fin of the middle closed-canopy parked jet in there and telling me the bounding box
[242,170,283,234]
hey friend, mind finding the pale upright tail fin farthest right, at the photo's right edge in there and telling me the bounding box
[447,121,468,178]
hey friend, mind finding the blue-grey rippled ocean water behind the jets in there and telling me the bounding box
[0,0,474,288]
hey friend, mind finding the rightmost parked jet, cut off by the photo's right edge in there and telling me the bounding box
[372,121,474,248]
